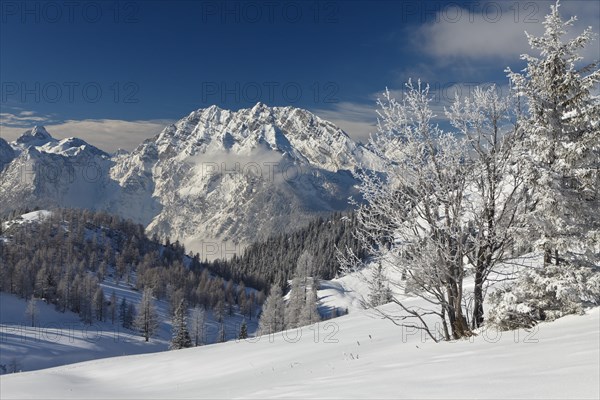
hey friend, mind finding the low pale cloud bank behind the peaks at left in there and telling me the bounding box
[0,113,174,152]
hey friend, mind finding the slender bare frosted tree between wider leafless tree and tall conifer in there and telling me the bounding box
[446,86,524,328]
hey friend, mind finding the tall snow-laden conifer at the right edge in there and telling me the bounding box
[507,1,600,265]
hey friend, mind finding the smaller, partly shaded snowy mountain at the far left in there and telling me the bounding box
[0,127,113,212]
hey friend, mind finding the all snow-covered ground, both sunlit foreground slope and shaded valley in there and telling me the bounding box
[0,252,600,399]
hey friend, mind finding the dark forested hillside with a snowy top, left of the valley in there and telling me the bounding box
[0,209,264,323]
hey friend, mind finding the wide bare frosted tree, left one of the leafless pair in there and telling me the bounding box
[340,81,471,340]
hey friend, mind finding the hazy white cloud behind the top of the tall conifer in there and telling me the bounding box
[414,0,600,64]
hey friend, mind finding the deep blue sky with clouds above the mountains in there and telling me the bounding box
[0,0,600,147]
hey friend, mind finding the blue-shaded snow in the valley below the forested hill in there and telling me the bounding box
[0,280,257,371]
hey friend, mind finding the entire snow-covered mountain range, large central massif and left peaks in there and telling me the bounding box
[0,103,377,258]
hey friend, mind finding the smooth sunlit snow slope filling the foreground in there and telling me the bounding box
[0,305,600,399]
